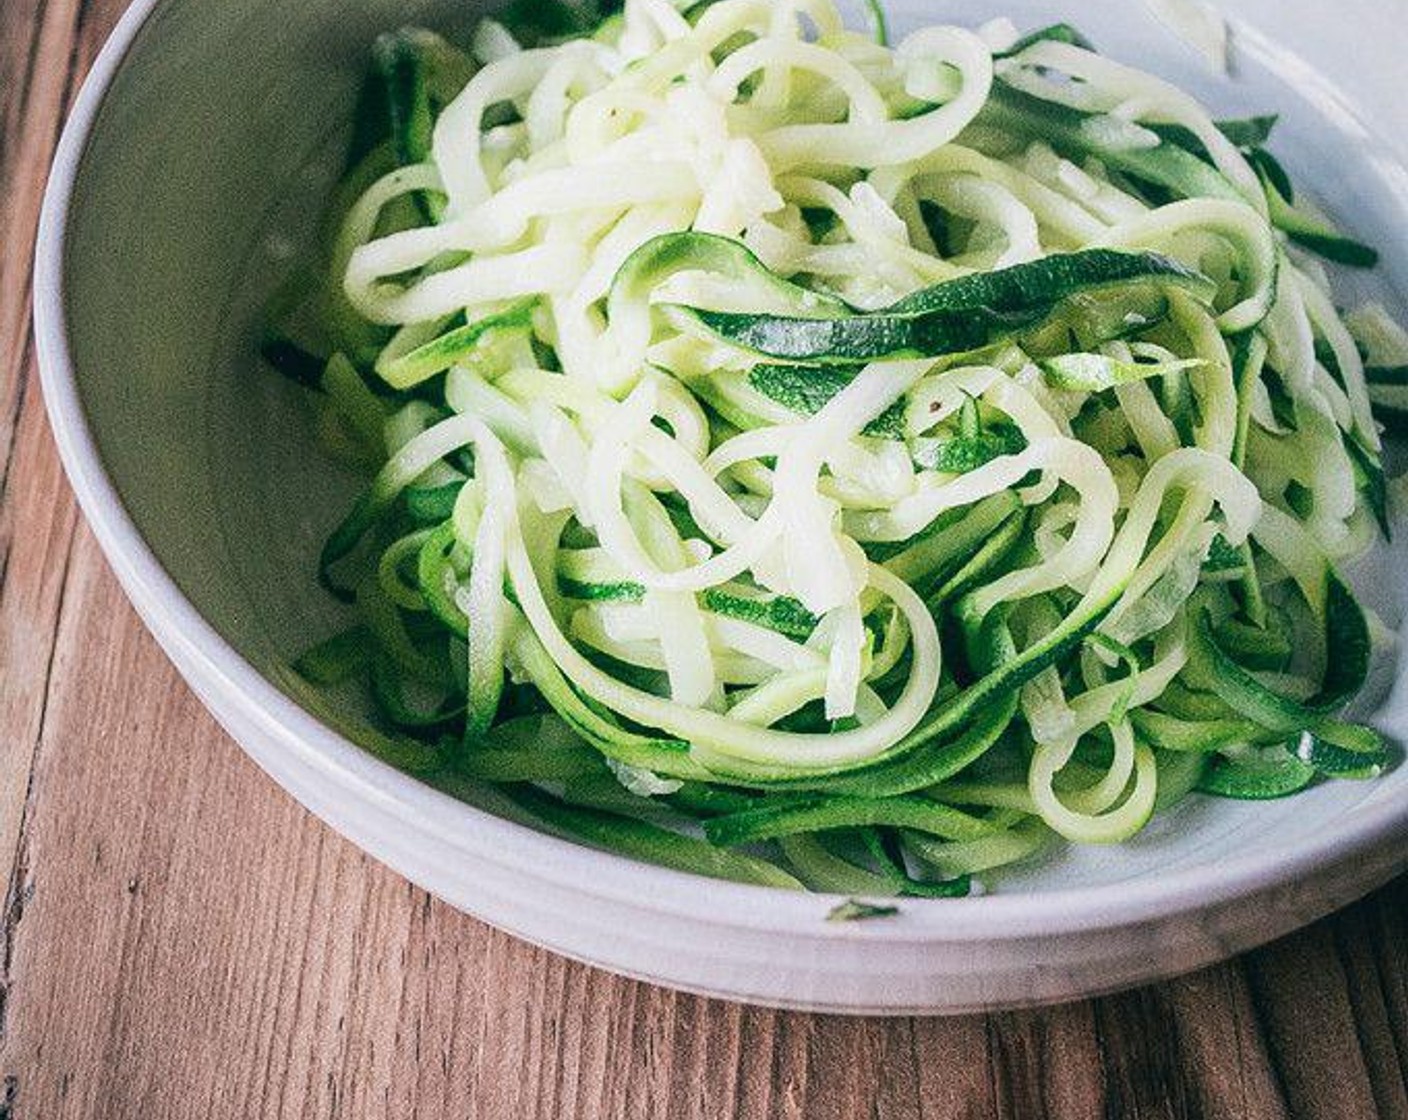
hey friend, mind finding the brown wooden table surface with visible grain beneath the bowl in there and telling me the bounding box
[0,0,1408,1120]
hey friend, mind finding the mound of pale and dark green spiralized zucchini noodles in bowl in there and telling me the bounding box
[266,0,1408,896]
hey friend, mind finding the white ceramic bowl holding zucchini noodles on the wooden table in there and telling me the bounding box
[35,0,1408,1013]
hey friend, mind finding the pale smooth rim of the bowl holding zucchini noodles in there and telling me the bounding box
[34,0,1408,945]
